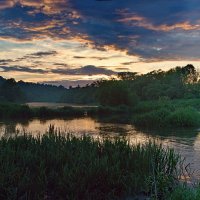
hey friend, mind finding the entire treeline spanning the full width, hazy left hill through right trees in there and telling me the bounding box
[0,65,200,106]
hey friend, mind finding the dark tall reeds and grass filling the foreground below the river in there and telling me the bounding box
[0,127,181,200]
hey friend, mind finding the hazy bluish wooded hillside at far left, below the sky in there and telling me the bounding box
[0,77,66,103]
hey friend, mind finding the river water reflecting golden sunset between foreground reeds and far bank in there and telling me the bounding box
[0,117,200,177]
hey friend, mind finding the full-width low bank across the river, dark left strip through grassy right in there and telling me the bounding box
[0,99,200,128]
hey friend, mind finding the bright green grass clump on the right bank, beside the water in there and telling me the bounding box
[132,99,200,127]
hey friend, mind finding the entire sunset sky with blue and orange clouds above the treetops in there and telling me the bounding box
[0,0,200,87]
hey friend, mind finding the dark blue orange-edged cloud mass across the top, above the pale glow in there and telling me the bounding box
[0,0,200,60]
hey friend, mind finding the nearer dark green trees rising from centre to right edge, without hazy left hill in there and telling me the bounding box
[62,64,200,106]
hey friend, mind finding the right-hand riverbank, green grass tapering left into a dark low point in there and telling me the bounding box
[91,99,200,129]
